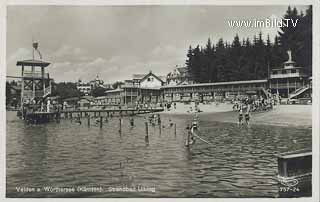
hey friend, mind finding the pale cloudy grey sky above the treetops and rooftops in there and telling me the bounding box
[6,5,307,83]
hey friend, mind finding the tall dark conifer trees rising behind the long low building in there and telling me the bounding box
[186,6,312,83]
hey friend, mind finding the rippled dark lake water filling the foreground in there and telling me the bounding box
[6,112,312,197]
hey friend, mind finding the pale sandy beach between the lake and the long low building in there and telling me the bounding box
[162,104,312,127]
